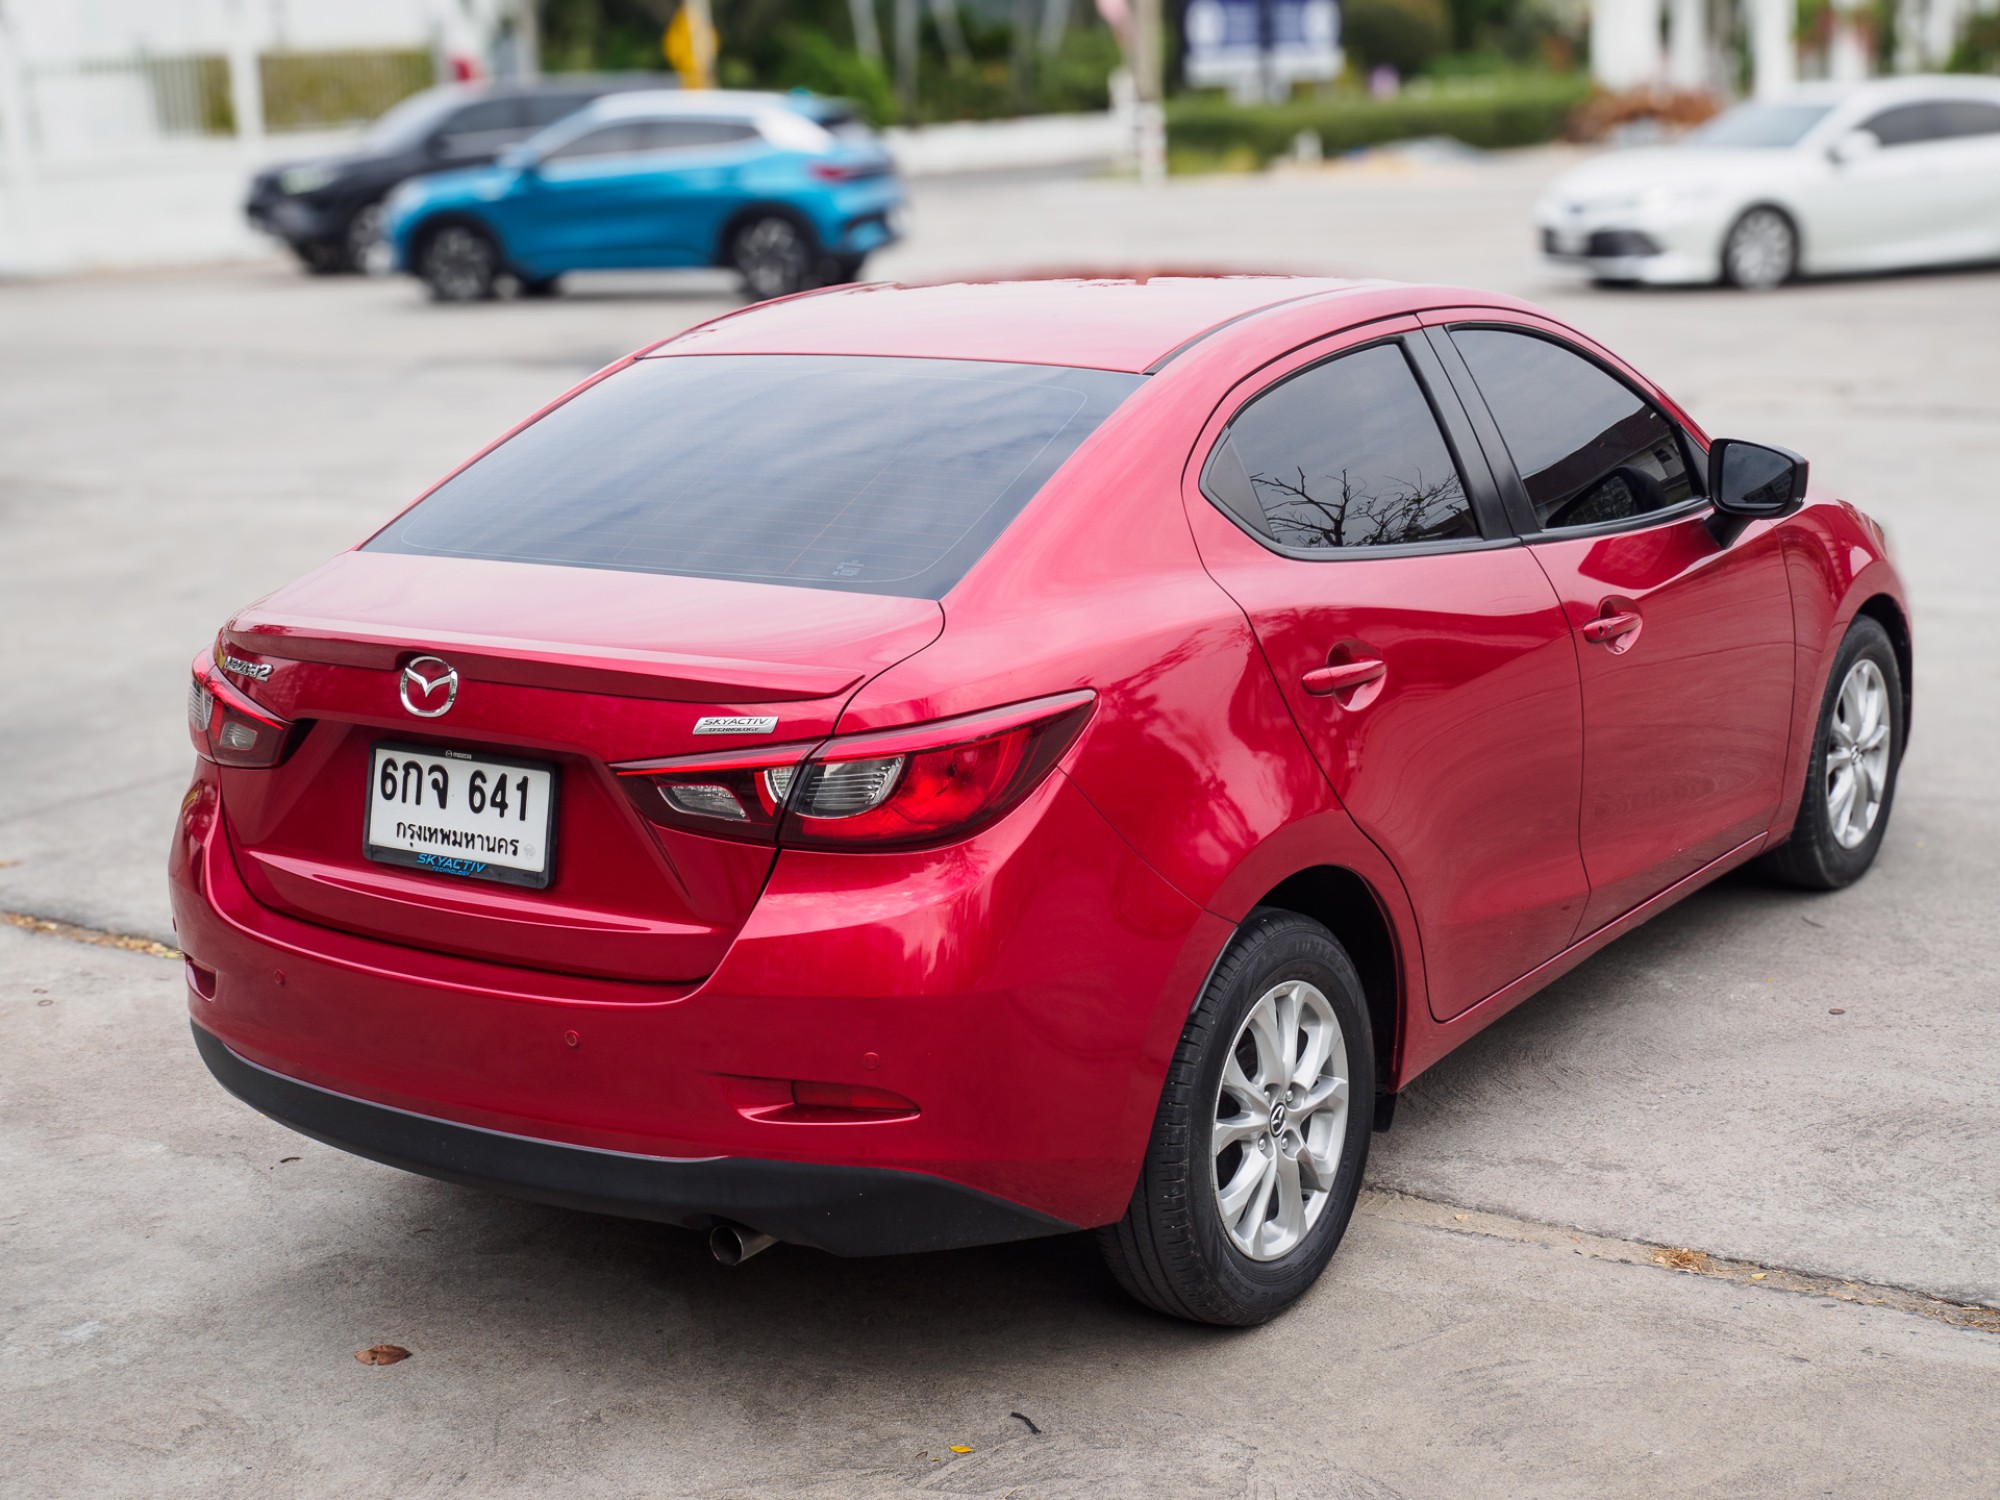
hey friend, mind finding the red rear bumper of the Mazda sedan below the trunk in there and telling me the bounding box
[170,768,1230,1252]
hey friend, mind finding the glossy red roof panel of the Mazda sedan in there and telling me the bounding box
[648,276,1480,374]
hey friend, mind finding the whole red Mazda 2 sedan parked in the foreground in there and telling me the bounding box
[172,278,1910,1324]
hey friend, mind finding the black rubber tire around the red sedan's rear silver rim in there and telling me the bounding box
[1098,910,1374,1328]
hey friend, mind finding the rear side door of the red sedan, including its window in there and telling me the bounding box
[1186,318,1588,1018]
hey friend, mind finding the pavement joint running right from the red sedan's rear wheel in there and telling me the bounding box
[1360,1188,2000,1334]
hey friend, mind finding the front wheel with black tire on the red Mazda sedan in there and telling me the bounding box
[1762,614,1904,890]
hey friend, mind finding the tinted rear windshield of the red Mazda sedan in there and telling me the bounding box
[368,354,1144,598]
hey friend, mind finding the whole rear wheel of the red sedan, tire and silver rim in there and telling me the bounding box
[1098,910,1374,1326]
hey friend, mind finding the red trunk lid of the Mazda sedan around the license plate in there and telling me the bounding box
[211,552,944,982]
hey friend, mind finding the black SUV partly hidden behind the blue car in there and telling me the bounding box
[244,74,676,274]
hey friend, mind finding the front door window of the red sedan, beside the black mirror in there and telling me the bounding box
[1452,328,1694,530]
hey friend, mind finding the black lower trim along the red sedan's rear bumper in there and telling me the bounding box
[194,1026,1076,1256]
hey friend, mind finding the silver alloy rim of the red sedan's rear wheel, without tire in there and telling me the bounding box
[1210,980,1348,1260]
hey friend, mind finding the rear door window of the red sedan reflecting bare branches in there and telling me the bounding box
[1202,342,1480,550]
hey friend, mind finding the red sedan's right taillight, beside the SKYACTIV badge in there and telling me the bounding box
[616,690,1096,850]
